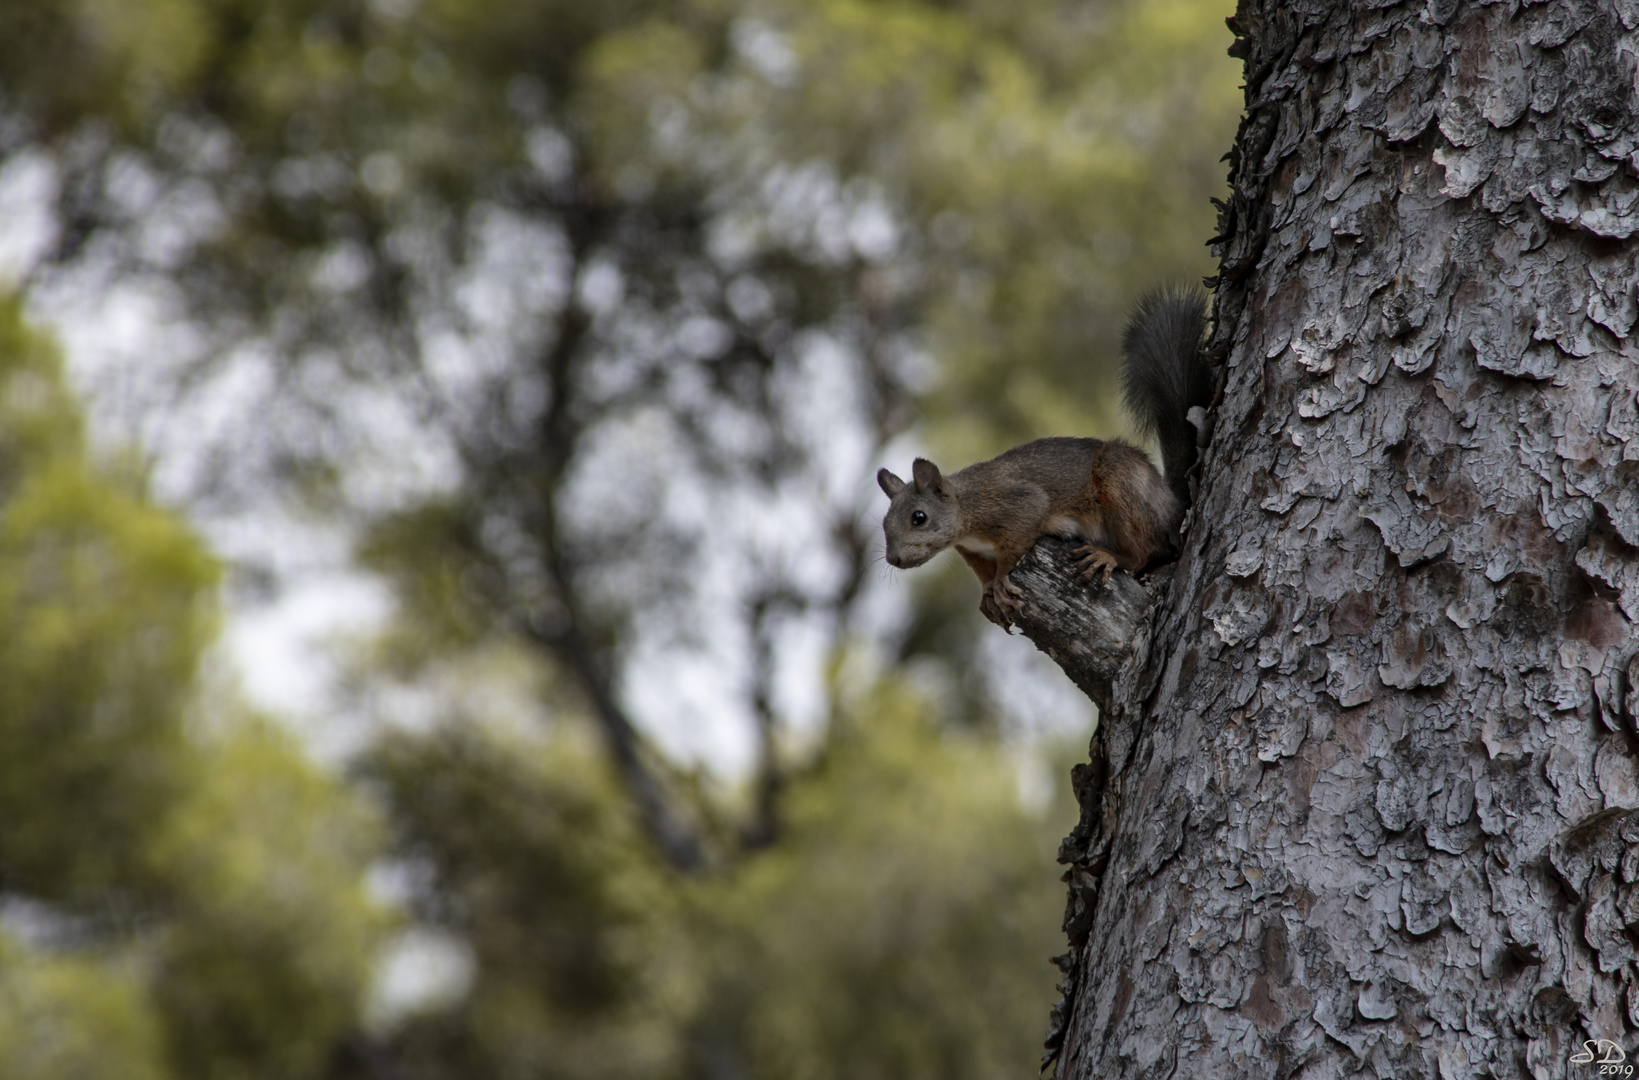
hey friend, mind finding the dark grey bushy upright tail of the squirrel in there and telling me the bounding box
[1121,285,1213,506]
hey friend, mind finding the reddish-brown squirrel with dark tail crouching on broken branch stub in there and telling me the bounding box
[877,287,1214,629]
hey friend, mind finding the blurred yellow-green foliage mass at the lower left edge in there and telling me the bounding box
[0,300,385,1080]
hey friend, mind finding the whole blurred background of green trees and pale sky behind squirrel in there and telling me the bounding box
[0,0,1239,1080]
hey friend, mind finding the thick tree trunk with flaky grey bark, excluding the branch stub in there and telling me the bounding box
[1049,0,1639,1080]
